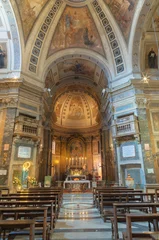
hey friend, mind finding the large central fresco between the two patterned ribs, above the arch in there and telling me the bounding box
[48,6,104,56]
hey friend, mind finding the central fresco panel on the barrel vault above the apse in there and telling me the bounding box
[58,59,95,78]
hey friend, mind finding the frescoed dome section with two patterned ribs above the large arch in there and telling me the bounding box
[12,0,143,79]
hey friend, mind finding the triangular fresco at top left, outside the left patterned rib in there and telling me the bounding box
[16,0,48,40]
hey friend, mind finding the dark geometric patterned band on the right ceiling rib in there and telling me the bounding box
[92,0,125,74]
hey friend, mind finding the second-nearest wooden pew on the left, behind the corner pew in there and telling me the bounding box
[0,207,48,239]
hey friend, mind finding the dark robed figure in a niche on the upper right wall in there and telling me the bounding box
[145,44,158,69]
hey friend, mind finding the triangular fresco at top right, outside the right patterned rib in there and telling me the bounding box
[104,0,139,38]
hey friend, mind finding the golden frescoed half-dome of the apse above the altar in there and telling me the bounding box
[54,91,99,128]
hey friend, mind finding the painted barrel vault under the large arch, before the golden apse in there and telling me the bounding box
[45,56,108,90]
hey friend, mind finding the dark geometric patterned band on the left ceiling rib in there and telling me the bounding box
[29,0,63,73]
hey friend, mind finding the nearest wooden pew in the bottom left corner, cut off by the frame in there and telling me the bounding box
[0,220,35,240]
